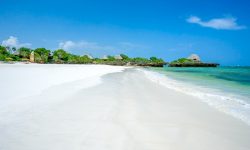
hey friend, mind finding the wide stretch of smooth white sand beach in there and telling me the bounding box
[0,64,250,150]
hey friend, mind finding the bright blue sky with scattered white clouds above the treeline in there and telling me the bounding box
[0,0,250,65]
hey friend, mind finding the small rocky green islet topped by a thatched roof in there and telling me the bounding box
[168,54,219,67]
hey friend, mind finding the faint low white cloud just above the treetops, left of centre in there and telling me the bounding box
[58,40,114,51]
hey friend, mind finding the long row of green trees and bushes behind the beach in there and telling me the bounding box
[0,46,166,67]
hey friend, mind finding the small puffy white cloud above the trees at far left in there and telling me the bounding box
[1,36,31,48]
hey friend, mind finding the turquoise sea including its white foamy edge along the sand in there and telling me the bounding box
[147,67,250,125]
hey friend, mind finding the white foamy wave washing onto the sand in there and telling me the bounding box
[138,69,250,125]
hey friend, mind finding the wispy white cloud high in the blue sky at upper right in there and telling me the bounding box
[186,16,246,30]
